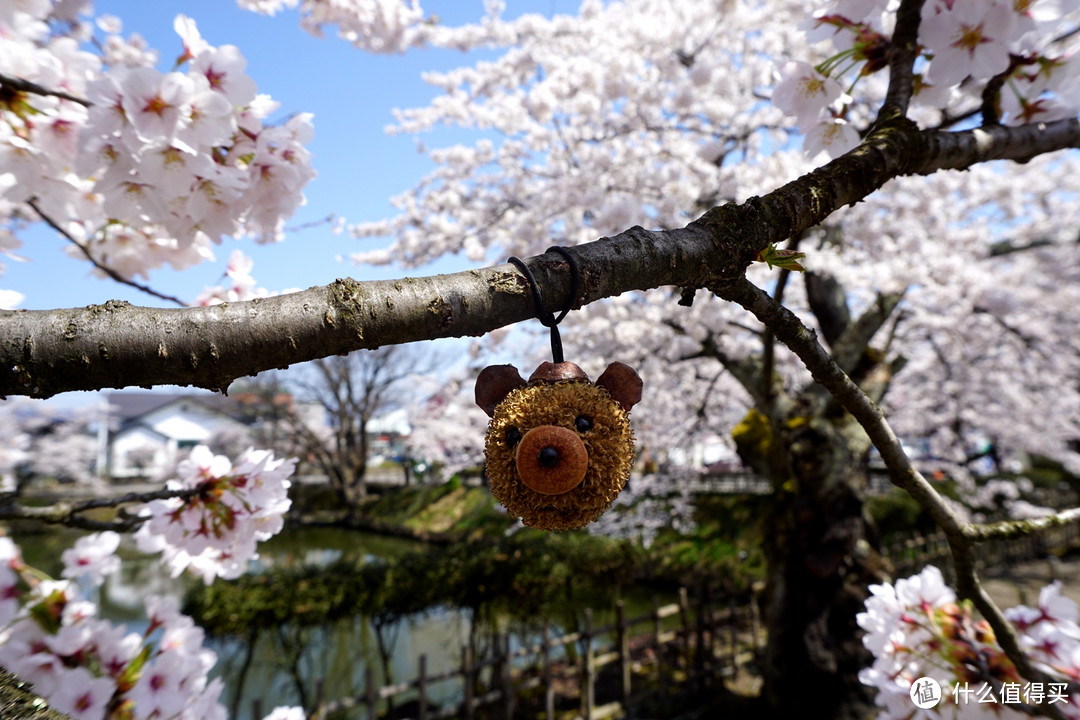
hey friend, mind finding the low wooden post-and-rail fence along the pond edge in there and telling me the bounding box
[304,588,761,720]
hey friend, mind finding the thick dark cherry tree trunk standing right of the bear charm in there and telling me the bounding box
[759,413,882,719]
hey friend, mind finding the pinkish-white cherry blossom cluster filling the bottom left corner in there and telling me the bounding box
[0,532,226,720]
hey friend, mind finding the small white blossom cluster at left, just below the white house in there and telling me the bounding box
[135,445,296,585]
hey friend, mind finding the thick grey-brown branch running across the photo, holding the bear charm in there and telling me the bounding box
[0,119,1080,397]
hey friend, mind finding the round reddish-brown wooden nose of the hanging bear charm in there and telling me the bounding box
[516,425,589,495]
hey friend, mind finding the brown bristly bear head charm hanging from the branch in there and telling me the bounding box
[476,363,642,530]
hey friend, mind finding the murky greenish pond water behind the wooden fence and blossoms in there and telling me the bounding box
[15,527,671,720]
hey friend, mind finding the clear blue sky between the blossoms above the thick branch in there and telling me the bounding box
[8,0,561,310]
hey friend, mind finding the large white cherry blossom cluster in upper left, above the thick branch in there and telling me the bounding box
[0,0,314,289]
